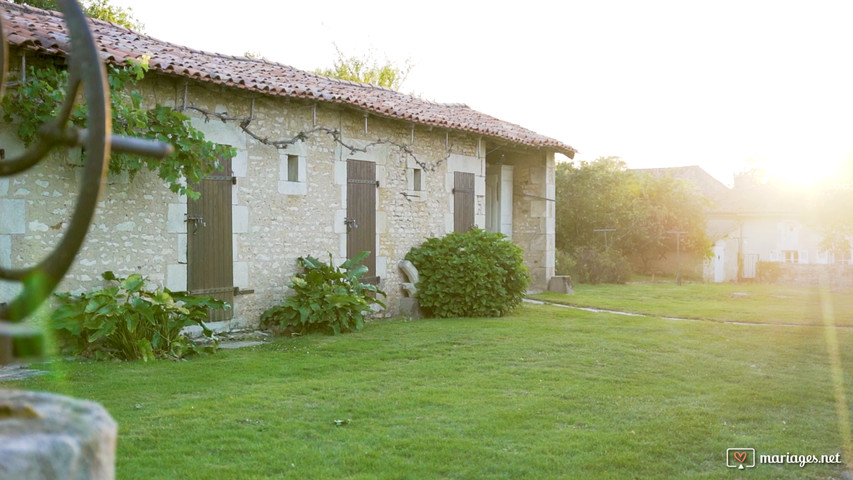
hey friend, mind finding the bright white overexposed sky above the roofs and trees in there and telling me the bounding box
[110,0,853,185]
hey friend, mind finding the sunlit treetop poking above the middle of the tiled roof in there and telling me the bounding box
[314,45,412,90]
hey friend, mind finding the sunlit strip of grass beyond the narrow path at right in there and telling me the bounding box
[532,283,853,326]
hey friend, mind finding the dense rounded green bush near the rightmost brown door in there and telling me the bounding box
[406,229,530,318]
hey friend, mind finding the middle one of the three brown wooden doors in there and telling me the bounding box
[346,160,379,283]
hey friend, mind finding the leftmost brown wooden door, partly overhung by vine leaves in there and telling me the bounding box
[187,158,234,322]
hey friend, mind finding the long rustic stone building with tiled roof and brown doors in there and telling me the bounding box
[0,2,574,328]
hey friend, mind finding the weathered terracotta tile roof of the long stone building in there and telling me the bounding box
[0,1,575,157]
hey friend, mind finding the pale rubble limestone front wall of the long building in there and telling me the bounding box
[0,68,554,328]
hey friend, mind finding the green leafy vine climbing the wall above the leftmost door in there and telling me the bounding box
[3,57,236,198]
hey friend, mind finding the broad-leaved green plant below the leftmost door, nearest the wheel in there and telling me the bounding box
[50,272,229,361]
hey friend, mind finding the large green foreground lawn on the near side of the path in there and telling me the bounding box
[2,287,853,479]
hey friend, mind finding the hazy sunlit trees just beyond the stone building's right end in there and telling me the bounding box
[556,157,710,280]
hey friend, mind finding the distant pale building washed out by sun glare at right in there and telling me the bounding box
[634,165,853,288]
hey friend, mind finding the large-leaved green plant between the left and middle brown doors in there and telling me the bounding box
[261,252,385,335]
